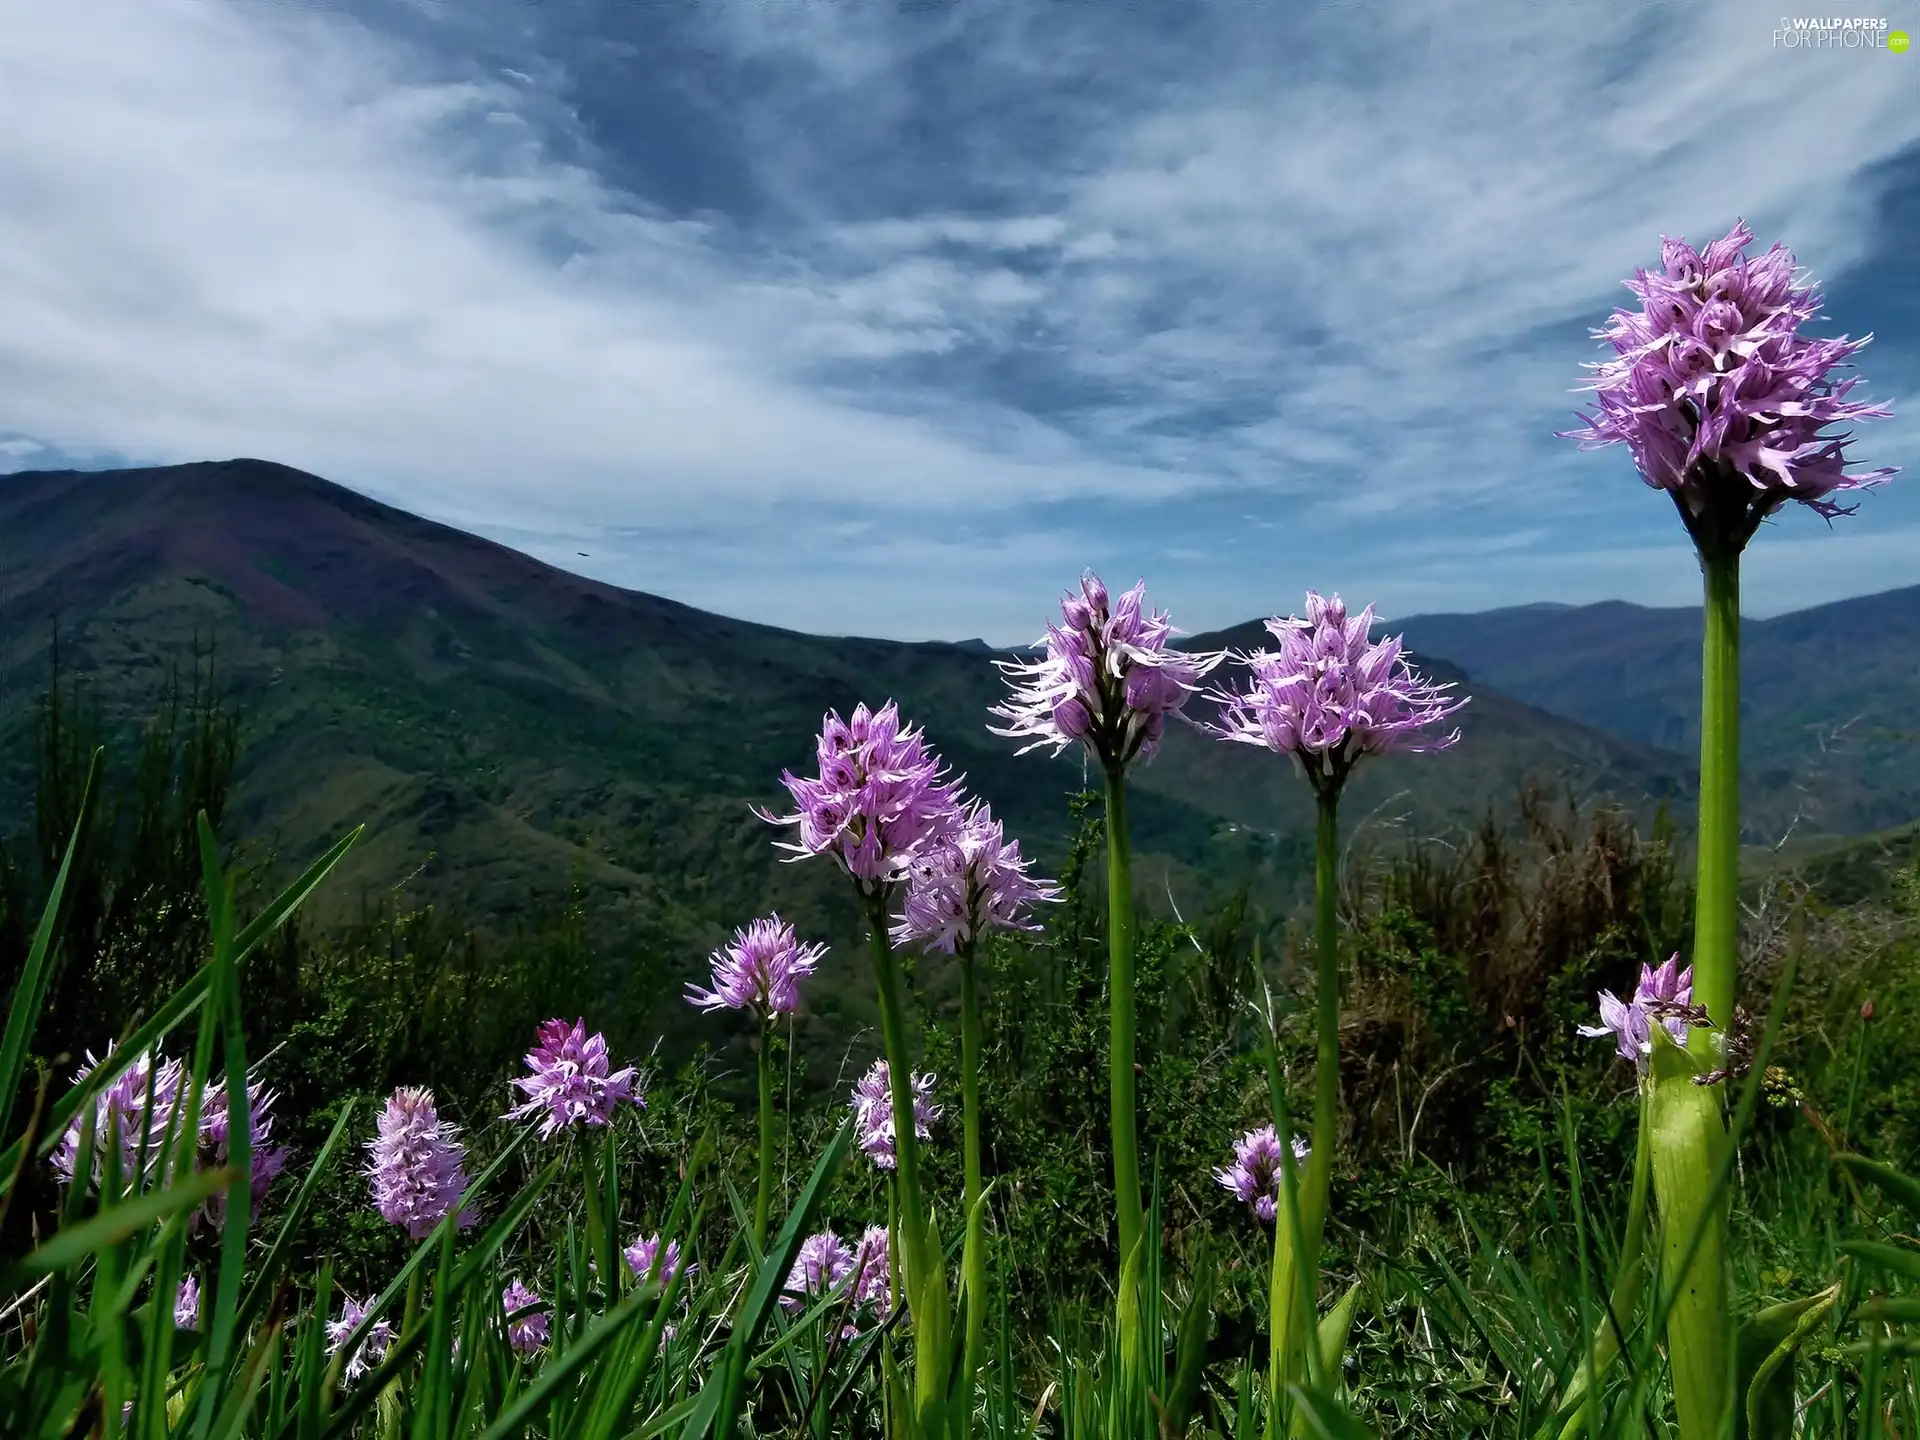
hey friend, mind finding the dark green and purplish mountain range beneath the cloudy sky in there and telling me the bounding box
[0,459,1920,1006]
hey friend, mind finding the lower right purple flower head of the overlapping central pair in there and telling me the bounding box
[893,801,1062,954]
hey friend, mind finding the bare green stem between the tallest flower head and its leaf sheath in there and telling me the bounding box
[1692,553,1740,1060]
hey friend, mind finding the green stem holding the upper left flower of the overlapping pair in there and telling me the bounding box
[868,913,950,1440]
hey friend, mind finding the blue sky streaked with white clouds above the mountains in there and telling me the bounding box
[0,0,1920,641]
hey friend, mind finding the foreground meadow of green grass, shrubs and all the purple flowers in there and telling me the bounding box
[0,216,1920,1440]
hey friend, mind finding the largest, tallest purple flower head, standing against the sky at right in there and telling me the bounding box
[1563,221,1893,553]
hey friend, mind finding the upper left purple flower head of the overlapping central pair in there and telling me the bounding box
[755,701,960,893]
